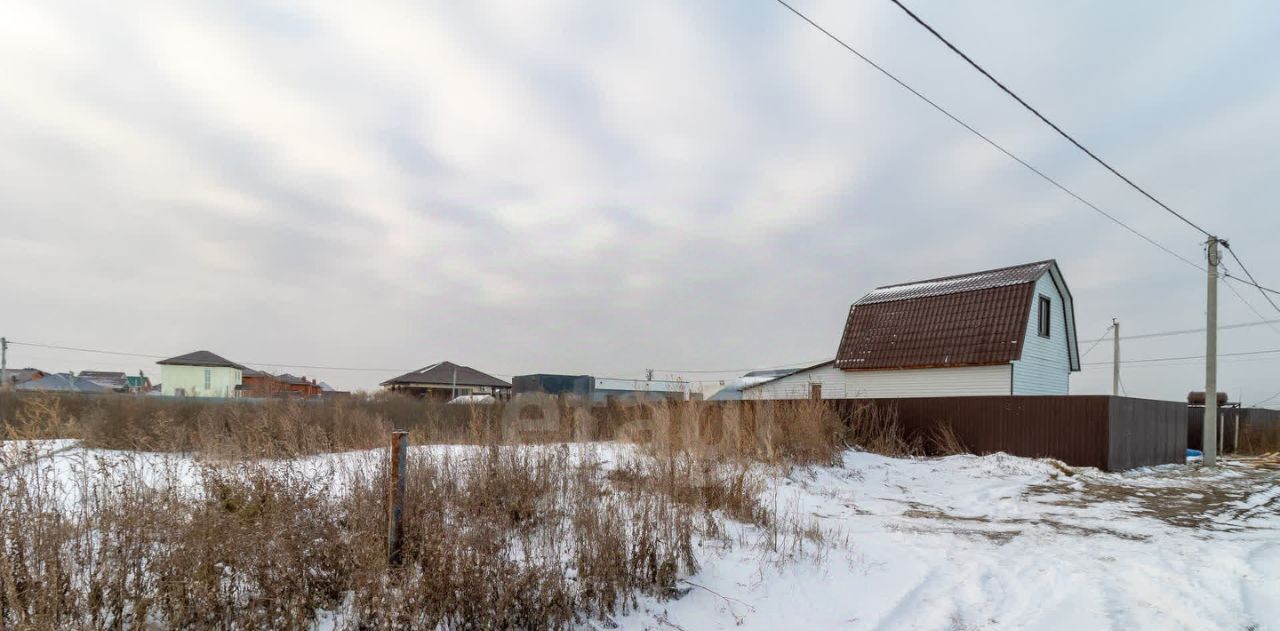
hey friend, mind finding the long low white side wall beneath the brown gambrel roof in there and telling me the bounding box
[742,363,1010,399]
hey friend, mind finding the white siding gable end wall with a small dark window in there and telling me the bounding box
[1014,274,1071,394]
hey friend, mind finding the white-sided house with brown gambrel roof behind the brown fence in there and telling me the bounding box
[744,261,1080,399]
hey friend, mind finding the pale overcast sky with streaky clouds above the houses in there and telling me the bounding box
[0,0,1280,403]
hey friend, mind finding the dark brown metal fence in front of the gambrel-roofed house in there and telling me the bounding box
[833,395,1187,471]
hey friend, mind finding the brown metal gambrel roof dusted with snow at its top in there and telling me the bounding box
[836,261,1055,370]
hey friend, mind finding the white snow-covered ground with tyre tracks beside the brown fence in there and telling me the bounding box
[5,442,1280,631]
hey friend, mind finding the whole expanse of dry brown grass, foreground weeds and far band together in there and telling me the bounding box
[0,397,844,628]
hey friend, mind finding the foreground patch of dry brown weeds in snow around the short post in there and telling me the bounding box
[0,445,703,628]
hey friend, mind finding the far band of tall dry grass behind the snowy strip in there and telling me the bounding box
[0,393,860,465]
